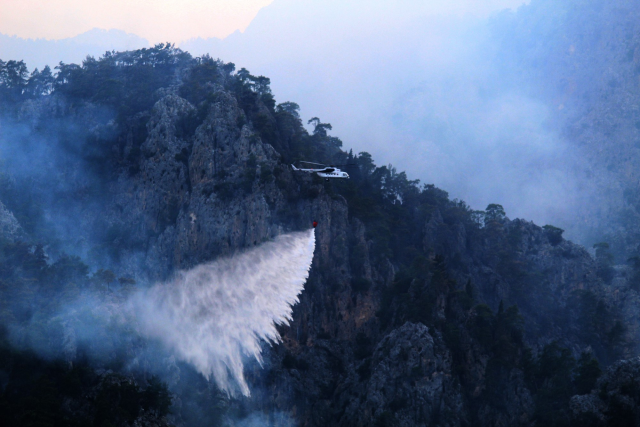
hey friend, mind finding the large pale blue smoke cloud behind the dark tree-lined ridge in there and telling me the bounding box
[181,0,600,238]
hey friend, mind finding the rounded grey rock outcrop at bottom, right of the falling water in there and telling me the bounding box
[341,323,466,427]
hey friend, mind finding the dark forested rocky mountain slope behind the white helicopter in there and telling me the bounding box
[0,45,640,426]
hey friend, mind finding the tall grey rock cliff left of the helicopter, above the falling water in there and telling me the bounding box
[112,90,282,278]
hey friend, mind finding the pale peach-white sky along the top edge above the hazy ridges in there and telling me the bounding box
[0,0,525,44]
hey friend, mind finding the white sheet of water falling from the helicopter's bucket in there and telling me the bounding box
[130,229,315,396]
